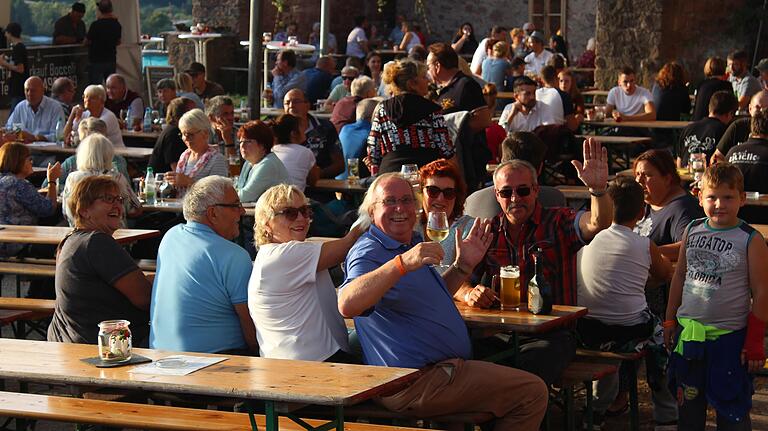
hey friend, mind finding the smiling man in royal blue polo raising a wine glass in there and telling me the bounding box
[339,174,547,430]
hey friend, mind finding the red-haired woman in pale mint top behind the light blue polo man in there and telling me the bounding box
[237,120,288,202]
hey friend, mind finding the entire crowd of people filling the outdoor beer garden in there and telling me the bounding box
[0,4,768,430]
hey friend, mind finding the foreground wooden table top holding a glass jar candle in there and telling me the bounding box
[0,340,419,405]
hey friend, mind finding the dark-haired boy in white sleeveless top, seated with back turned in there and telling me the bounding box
[576,177,676,425]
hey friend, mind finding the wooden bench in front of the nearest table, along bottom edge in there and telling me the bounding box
[0,392,432,431]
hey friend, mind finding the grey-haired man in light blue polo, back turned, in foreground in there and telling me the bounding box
[149,176,259,354]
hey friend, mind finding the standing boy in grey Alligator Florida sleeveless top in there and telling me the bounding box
[664,163,768,430]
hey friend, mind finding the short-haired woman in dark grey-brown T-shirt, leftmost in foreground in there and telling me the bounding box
[48,175,152,346]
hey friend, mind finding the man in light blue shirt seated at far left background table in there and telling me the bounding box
[5,76,66,143]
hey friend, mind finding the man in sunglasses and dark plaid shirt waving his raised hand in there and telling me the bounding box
[463,139,613,384]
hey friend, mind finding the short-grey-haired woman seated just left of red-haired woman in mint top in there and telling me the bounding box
[165,109,229,194]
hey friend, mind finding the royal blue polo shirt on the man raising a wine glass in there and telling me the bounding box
[341,226,472,368]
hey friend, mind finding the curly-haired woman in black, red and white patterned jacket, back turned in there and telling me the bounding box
[365,60,455,174]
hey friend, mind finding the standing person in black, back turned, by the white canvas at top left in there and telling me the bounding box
[85,0,123,84]
